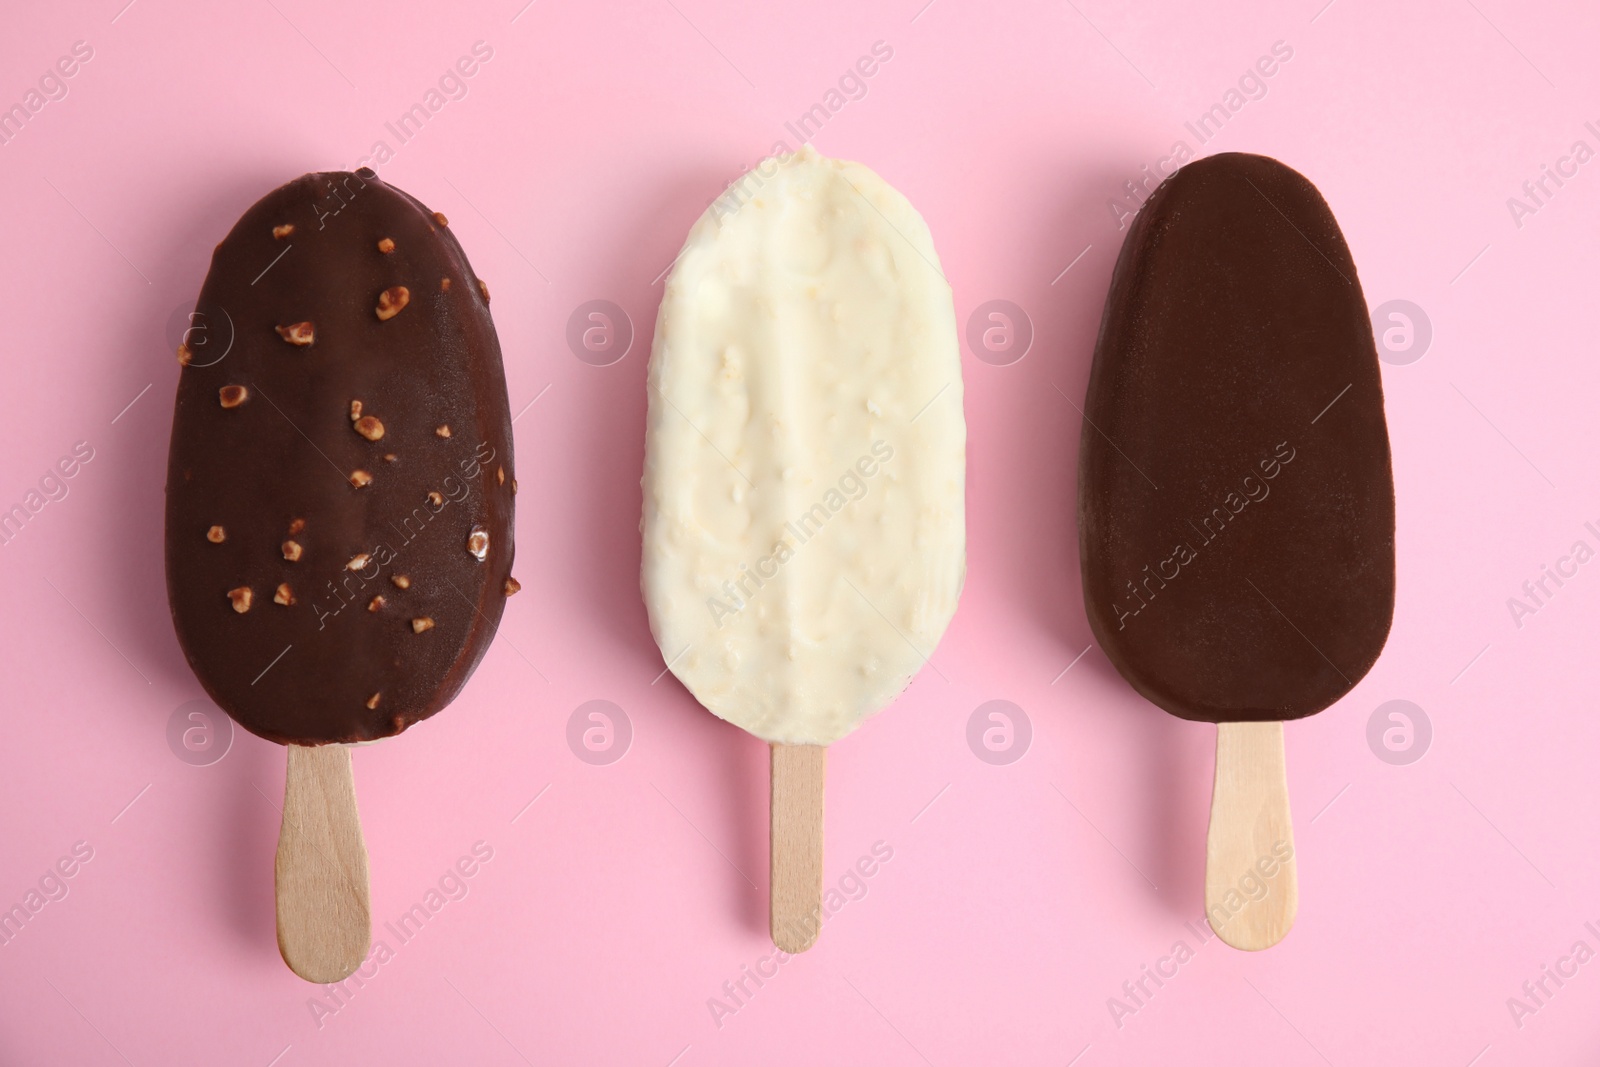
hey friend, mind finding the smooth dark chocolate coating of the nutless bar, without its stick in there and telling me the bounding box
[1078,154,1395,723]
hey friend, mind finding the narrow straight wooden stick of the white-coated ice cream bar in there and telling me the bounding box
[771,744,827,952]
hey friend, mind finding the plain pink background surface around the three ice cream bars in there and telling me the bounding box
[0,0,1600,1067]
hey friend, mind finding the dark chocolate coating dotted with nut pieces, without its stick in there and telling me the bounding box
[166,170,515,744]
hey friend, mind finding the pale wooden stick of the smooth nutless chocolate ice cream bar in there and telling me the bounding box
[1205,723,1299,952]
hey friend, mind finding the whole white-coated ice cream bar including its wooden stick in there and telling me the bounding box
[642,149,966,952]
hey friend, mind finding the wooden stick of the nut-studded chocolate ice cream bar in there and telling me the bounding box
[274,744,373,984]
